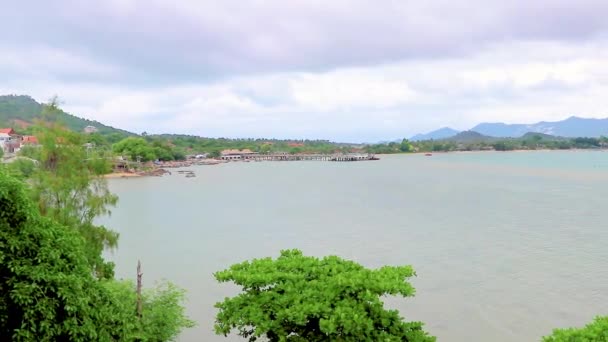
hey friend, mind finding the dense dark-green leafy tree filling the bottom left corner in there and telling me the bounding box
[0,171,117,341]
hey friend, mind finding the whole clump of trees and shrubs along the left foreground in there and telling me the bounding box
[0,102,193,341]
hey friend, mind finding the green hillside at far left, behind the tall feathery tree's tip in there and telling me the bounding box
[0,95,133,135]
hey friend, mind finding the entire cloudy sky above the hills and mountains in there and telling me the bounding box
[0,0,608,142]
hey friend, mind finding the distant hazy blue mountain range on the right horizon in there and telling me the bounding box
[411,116,608,141]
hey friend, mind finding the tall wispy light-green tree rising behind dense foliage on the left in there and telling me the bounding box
[30,101,118,277]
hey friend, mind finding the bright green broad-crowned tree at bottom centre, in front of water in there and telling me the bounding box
[215,250,435,342]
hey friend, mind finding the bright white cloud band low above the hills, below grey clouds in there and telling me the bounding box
[0,41,608,141]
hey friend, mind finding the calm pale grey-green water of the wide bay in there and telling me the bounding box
[104,152,608,342]
